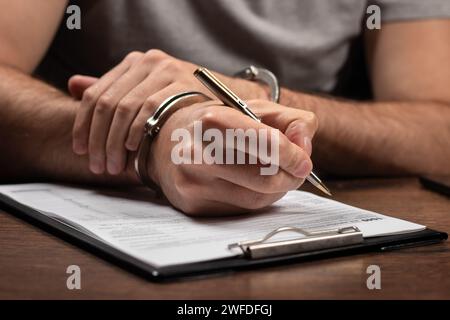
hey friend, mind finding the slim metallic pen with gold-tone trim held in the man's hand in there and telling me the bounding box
[194,68,331,196]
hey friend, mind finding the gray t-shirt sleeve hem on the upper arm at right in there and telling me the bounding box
[369,0,450,22]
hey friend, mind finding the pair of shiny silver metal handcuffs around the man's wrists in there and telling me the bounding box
[134,66,280,190]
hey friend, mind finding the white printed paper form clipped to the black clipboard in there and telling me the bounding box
[0,184,425,267]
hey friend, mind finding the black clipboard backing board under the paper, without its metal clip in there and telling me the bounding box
[0,194,448,281]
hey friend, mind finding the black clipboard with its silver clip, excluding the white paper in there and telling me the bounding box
[0,194,448,282]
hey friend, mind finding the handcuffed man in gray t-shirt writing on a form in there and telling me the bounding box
[0,0,450,214]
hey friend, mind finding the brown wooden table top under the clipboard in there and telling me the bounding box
[0,179,450,299]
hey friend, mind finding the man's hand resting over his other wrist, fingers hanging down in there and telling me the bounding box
[69,50,267,175]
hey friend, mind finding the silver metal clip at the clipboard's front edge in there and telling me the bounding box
[228,226,364,259]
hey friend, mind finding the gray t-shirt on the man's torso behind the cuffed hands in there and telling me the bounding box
[36,0,450,92]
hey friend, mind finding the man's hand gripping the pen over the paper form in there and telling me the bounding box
[148,100,317,215]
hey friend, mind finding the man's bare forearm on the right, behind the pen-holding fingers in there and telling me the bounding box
[281,89,450,175]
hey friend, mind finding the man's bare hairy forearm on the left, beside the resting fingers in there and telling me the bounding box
[0,66,136,183]
